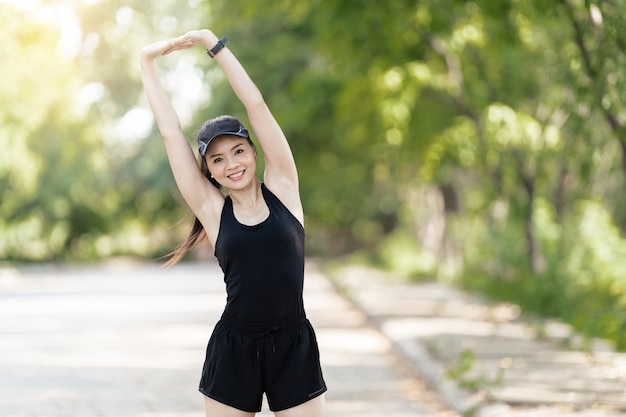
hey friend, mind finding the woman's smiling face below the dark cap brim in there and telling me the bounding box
[205,136,257,190]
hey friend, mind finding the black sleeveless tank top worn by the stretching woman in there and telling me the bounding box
[215,184,304,322]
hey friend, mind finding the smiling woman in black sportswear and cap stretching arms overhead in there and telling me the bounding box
[140,30,326,417]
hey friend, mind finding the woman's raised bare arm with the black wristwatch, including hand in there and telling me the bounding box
[181,29,303,221]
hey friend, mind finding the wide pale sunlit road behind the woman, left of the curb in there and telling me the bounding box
[0,262,458,417]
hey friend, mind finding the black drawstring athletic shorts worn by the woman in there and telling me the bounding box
[199,314,326,412]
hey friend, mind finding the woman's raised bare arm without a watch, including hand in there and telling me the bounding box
[140,39,224,224]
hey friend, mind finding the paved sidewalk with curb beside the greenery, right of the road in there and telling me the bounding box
[333,266,626,417]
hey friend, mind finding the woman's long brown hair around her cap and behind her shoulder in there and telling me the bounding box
[163,116,256,267]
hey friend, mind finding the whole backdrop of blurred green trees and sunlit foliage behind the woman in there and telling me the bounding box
[0,0,626,350]
